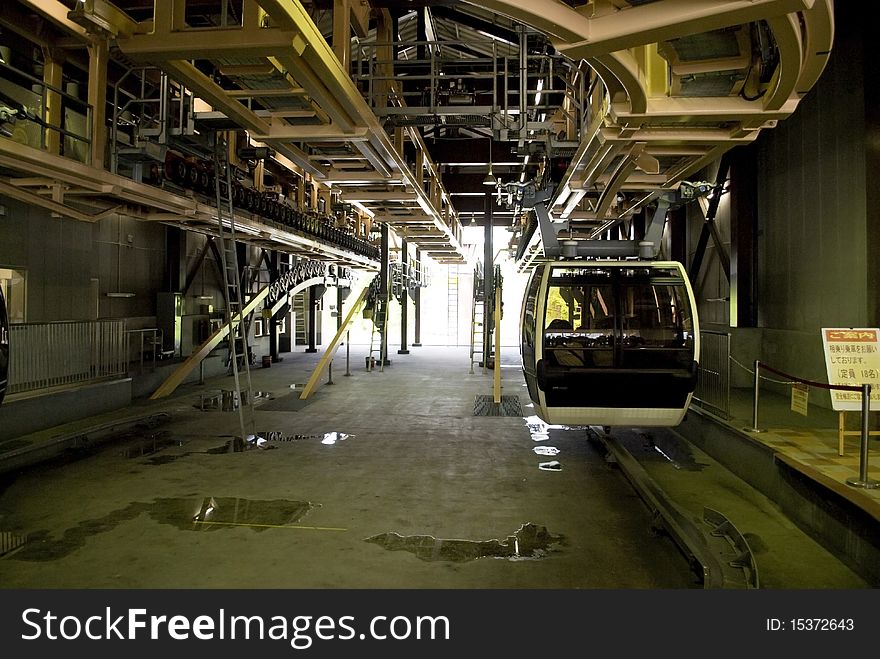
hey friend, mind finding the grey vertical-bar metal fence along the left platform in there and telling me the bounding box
[8,320,128,394]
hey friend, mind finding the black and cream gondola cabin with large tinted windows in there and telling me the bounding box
[520,260,700,426]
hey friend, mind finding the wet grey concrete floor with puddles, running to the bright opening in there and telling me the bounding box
[0,346,699,589]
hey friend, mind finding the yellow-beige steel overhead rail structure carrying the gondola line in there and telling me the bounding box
[0,0,834,269]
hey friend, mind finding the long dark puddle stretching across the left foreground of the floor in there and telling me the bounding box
[5,497,318,561]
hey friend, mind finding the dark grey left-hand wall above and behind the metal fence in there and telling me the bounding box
[0,196,278,356]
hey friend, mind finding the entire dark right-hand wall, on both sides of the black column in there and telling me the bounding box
[687,7,868,407]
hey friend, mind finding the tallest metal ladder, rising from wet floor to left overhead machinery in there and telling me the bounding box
[214,135,254,450]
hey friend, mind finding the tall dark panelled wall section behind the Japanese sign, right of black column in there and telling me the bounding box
[757,3,878,406]
